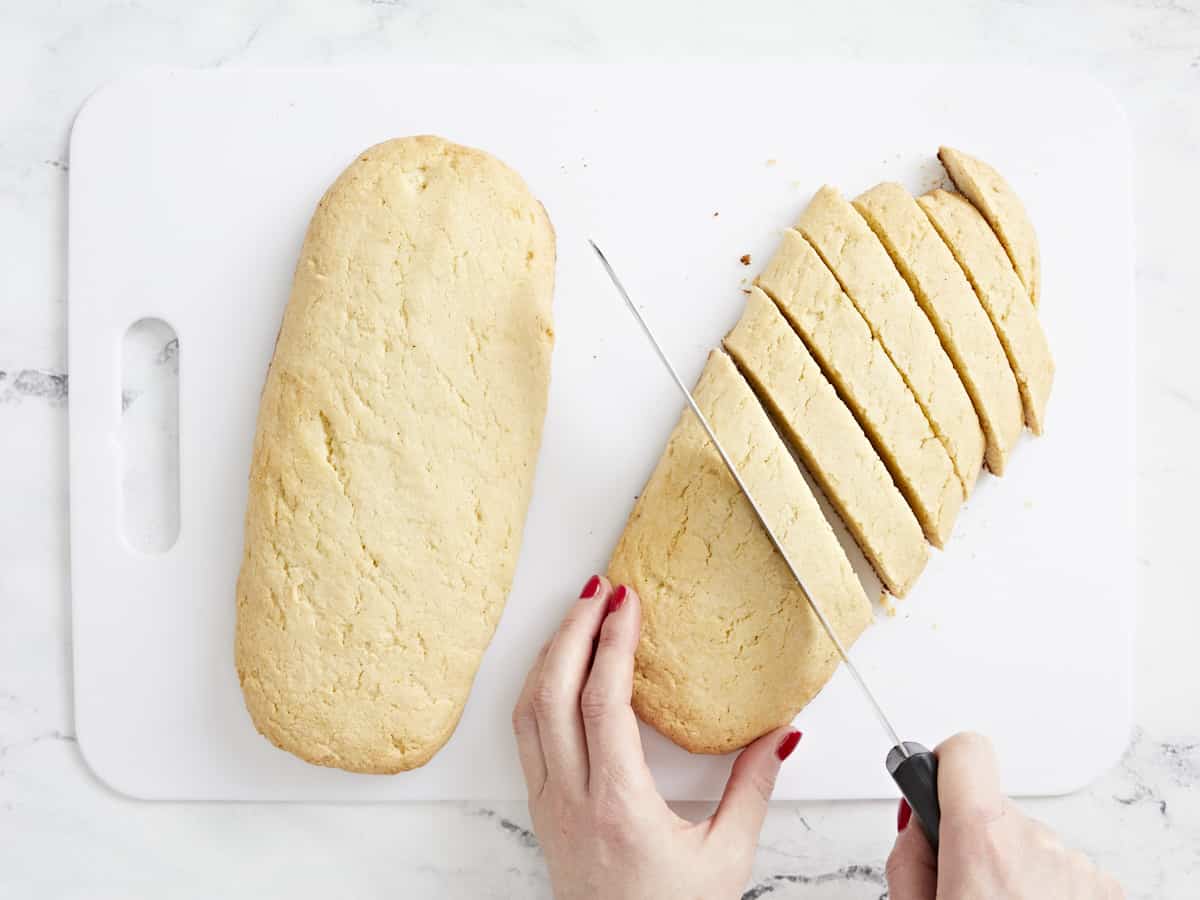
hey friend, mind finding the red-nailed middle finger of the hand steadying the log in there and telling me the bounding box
[533,575,612,790]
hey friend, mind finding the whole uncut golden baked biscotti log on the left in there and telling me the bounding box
[236,137,554,773]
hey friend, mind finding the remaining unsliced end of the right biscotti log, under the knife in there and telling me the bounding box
[608,350,871,754]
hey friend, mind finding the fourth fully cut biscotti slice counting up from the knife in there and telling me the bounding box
[854,181,1024,475]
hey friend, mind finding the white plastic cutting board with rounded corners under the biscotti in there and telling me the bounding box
[70,65,1136,802]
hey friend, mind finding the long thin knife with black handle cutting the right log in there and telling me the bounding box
[588,240,941,858]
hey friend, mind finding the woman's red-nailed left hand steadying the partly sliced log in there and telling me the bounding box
[512,577,800,900]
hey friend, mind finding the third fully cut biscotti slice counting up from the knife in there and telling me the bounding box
[796,186,984,496]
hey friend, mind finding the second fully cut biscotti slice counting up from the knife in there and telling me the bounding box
[755,229,962,547]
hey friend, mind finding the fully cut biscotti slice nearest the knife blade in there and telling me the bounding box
[725,288,929,596]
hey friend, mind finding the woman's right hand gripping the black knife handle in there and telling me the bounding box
[887,734,1124,900]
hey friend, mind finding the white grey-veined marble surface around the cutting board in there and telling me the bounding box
[0,0,1200,900]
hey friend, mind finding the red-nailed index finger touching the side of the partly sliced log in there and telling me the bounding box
[580,584,649,788]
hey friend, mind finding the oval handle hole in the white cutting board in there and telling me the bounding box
[119,319,179,553]
